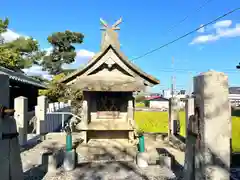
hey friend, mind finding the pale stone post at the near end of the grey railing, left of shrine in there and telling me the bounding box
[36,96,47,134]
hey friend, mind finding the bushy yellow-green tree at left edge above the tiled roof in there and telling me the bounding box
[0,18,45,70]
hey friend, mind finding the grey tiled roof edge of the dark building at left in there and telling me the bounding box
[0,66,46,88]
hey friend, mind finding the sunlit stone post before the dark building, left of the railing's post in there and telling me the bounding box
[14,96,28,146]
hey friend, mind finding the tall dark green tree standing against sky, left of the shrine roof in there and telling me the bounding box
[41,31,84,75]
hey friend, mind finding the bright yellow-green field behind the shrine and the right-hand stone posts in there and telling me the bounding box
[135,111,240,152]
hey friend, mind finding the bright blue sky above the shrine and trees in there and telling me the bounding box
[0,0,240,91]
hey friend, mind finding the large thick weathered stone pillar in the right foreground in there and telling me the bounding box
[194,71,231,180]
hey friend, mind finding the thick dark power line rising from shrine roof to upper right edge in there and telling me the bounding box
[131,8,240,61]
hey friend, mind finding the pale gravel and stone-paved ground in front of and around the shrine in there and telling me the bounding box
[21,133,184,180]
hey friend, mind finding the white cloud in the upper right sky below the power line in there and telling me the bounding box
[190,20,240,45]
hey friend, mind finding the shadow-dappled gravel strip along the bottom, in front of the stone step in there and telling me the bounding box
[44,162,175,180]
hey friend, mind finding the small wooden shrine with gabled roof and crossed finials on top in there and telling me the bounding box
[61,19,159,141]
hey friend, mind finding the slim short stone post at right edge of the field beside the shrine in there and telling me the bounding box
[169,97,179,135]
